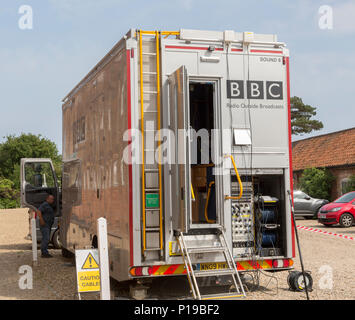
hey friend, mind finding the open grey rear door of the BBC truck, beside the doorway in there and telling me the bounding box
[169,66,191,232]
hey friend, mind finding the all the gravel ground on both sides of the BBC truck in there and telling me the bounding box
[0,209,355,300]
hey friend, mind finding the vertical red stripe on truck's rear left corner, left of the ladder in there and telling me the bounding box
[127,50,133,266]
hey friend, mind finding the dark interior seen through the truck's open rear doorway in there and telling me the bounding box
[189,81,218,224]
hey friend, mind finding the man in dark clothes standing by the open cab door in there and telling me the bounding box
[37,195,54,258]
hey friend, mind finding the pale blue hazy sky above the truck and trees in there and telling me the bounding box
[0,0,355,152]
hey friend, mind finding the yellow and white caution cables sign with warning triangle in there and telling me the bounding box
[75,249,101,293]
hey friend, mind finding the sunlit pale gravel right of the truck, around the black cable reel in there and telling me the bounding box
[247,216,355,300]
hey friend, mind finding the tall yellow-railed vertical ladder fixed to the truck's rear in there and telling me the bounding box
[137,30,179,258]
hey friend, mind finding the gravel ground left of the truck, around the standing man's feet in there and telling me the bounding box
[0,209,96,300]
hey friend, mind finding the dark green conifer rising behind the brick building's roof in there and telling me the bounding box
[291,97,323,135]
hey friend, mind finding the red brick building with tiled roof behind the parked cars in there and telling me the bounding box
[292,127,355,200]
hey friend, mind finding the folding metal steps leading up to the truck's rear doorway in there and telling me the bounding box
[177,229,246,300]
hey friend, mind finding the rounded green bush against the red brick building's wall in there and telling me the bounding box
[300,168,334,200]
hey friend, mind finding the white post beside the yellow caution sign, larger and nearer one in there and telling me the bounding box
[97,218,111,300]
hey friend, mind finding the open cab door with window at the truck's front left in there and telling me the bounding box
[20,159,59,215]
